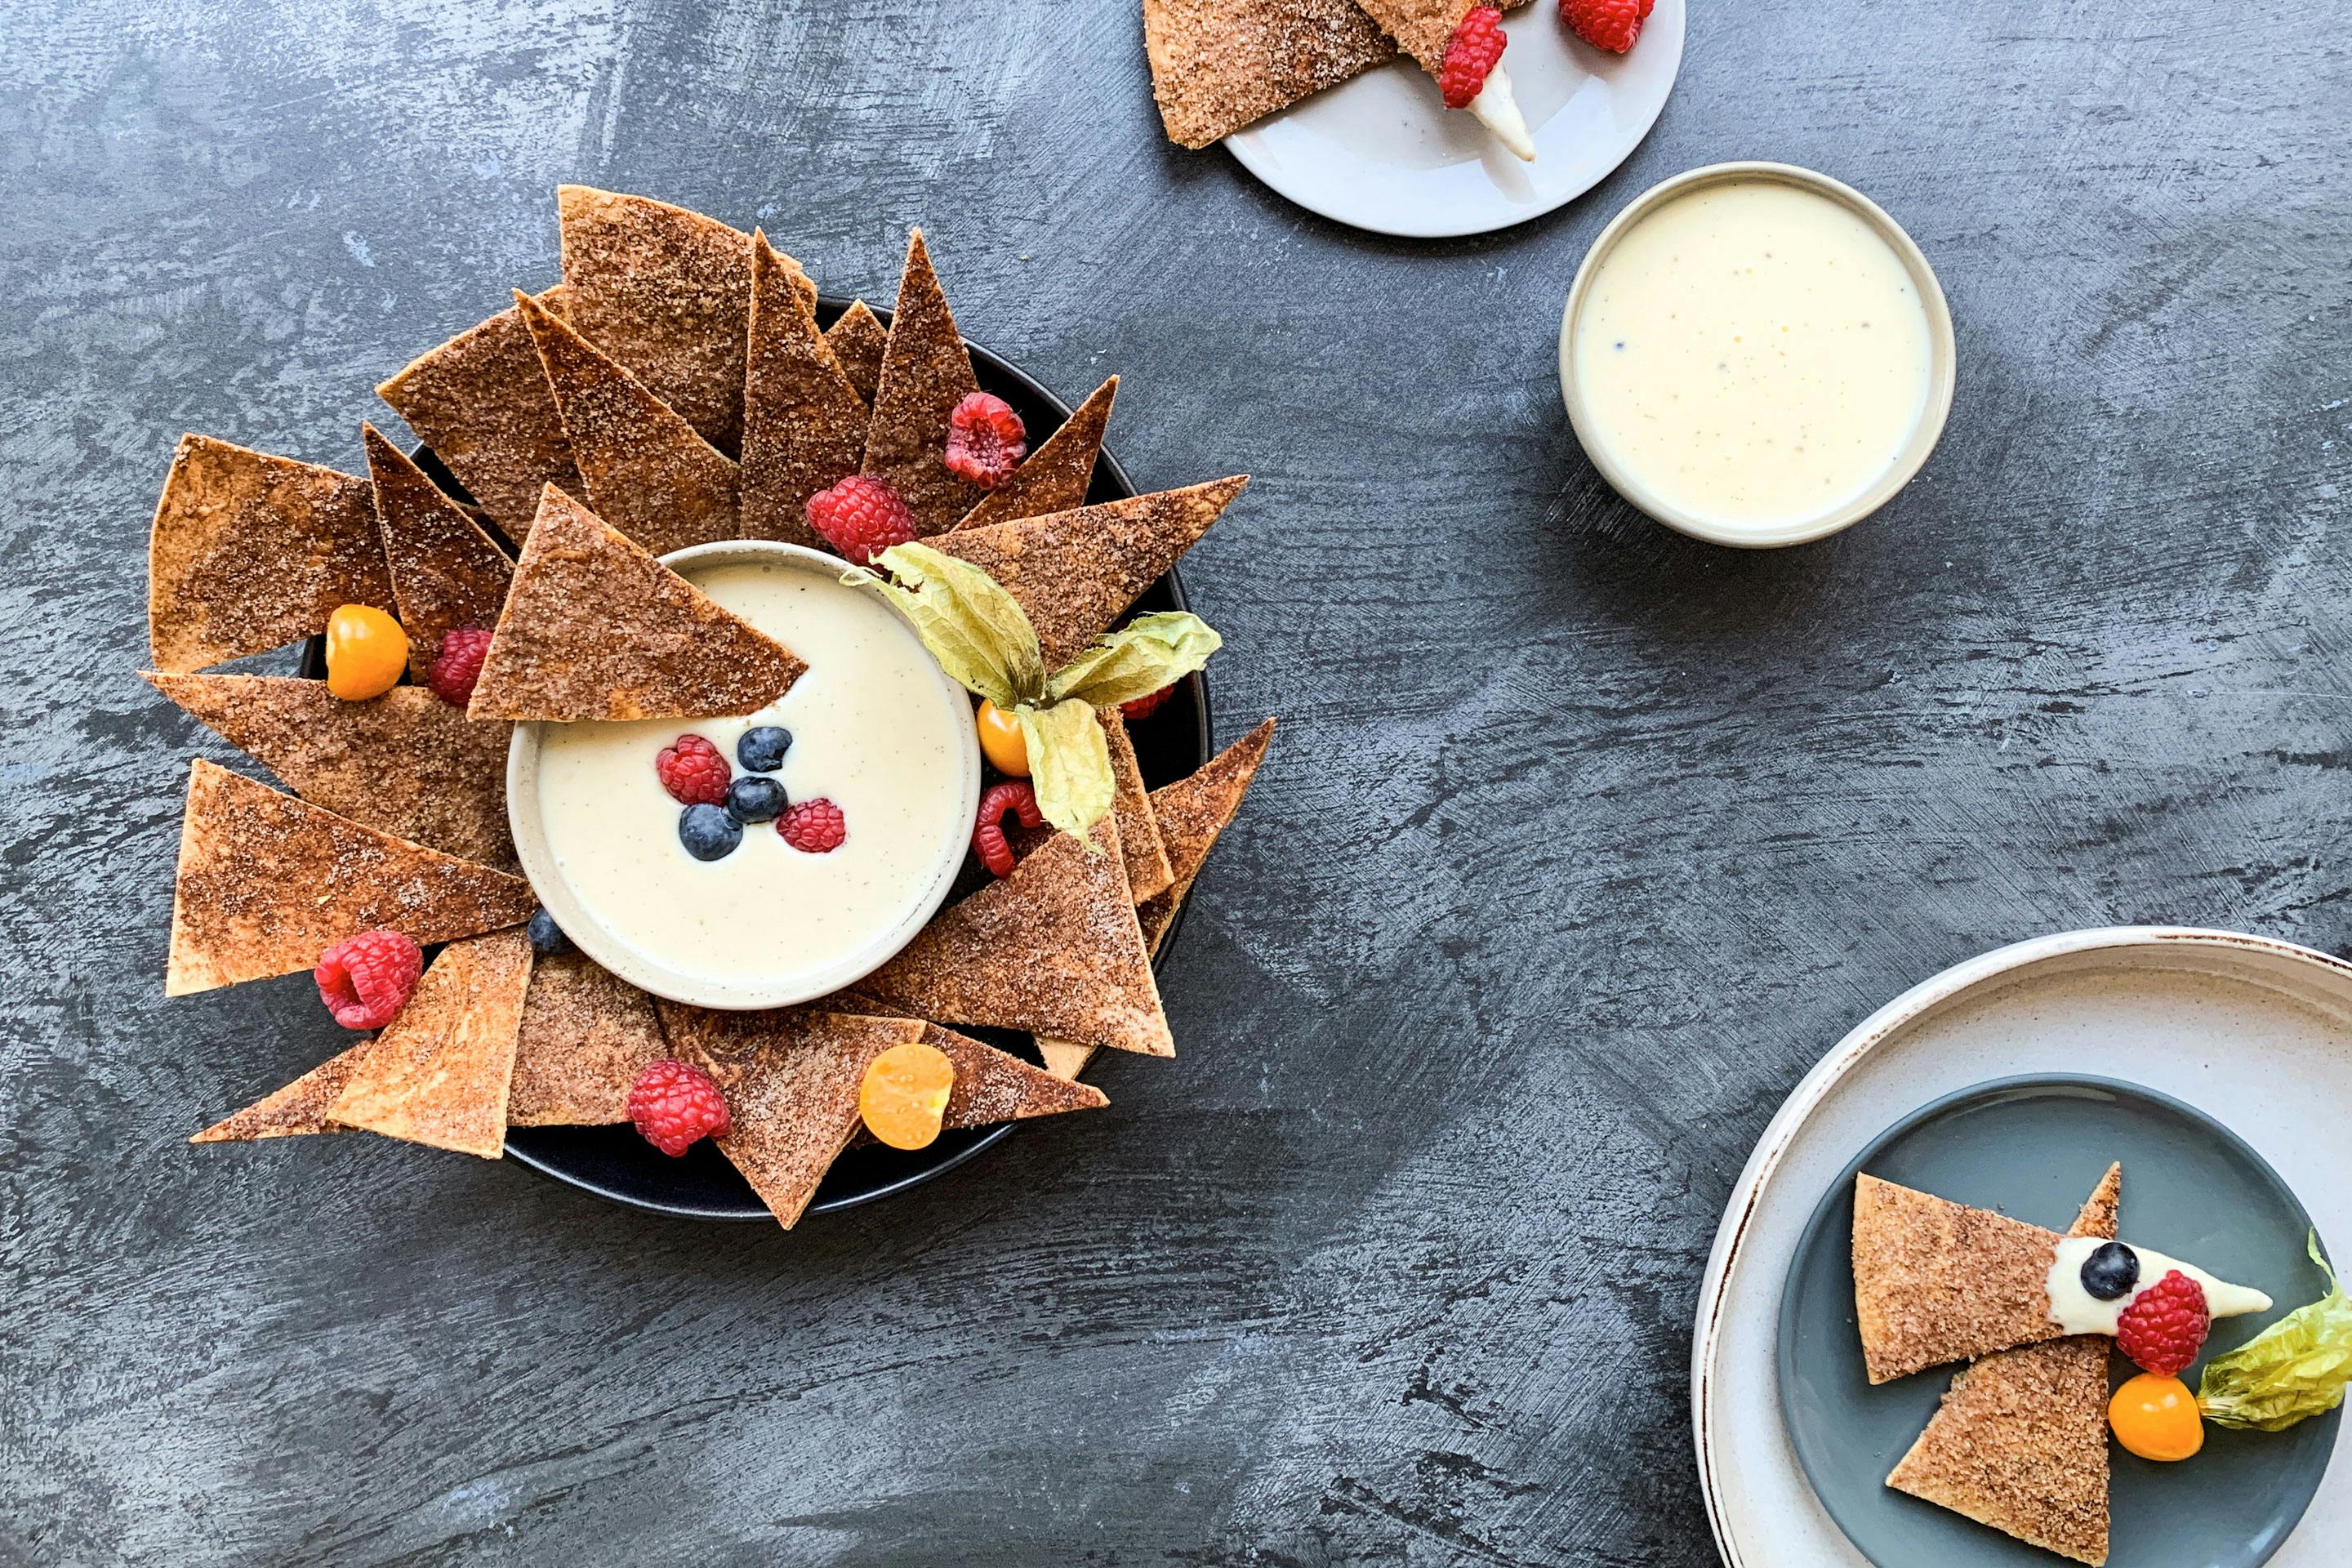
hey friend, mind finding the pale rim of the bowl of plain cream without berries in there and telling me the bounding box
[1559,160,1959,550]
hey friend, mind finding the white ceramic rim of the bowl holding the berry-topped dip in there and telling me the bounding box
[506,538,981,1011]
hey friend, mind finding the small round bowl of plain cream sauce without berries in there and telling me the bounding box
[1559,163,1957,548]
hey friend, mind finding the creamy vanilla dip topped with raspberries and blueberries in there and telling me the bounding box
[537,546,978,1006]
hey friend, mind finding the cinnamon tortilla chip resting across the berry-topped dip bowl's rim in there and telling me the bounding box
[468,484,807,722]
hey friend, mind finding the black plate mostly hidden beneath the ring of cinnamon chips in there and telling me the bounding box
[333,299,1211,1225]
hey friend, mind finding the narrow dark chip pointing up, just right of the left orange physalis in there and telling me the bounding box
[360,425,515,679]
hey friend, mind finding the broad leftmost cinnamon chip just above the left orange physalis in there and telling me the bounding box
[148,435,393,672]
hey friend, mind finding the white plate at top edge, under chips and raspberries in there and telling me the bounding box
[1225,0,1684,238]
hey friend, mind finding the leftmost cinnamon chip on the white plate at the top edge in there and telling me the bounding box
[1143,0,1397,148]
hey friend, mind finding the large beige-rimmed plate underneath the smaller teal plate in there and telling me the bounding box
[1691,926,2352,1568]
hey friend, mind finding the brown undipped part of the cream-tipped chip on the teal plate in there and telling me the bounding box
[1853,1175,2058,1383]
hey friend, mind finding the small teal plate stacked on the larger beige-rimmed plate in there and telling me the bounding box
[1778,1076,2342,1568]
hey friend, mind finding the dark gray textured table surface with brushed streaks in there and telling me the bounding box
[0,0,2352,1566]
